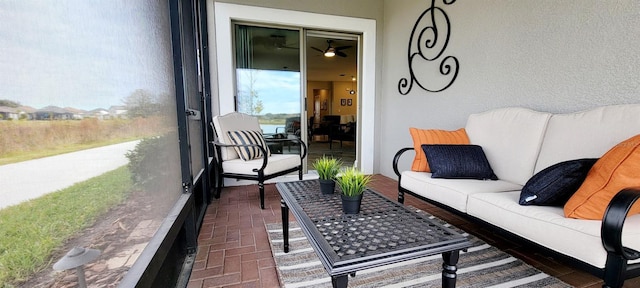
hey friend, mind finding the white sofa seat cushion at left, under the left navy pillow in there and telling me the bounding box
[400,171,522,213]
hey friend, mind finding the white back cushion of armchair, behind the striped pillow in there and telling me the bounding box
[213,112,262,161]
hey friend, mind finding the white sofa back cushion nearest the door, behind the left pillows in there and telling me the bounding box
[465,107,551,185]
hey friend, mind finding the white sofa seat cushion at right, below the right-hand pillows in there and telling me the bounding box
[467,191,640,268]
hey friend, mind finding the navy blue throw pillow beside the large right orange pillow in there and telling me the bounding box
[519,158,598,206]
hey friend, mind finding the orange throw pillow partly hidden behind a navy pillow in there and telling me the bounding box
[409,127,469,172]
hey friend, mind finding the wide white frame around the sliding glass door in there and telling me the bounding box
[212,0,376,174]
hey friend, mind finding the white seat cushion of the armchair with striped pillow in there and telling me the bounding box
[222,154,300,175]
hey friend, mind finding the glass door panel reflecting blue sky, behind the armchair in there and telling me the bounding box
[234,24,303,153]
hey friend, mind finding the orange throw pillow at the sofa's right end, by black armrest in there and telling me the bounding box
[564,134,640,220]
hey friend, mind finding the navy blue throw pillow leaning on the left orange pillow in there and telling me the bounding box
[422,144,498,180]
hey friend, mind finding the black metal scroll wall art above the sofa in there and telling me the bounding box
[398,0,459,95]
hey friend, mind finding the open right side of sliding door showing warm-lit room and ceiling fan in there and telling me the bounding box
[305,30,359,166]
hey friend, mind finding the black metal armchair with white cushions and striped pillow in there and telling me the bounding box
[210,112,307,209]
